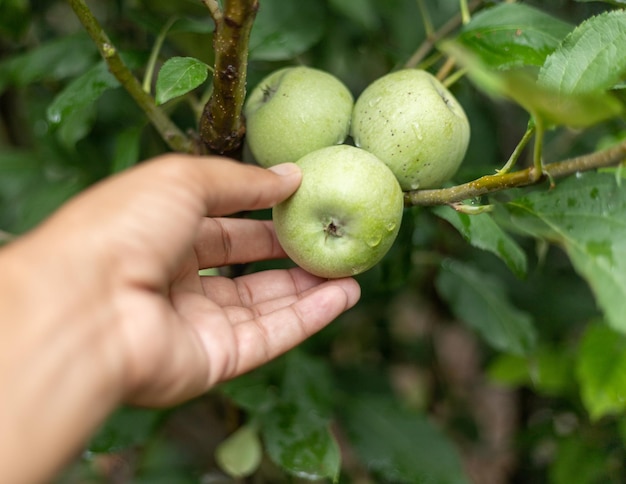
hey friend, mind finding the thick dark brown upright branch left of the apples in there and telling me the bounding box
[200,0,259,154]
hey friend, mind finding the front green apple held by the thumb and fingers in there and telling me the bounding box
[272,145,404,278]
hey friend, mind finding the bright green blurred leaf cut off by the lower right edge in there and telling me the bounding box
[576,324,626,420]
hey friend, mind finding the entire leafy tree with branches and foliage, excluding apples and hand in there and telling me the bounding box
[0,0,626,484]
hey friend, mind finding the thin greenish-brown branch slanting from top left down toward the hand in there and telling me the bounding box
[68,0,194,153]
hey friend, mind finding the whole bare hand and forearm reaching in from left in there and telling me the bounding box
[0,155,359,482]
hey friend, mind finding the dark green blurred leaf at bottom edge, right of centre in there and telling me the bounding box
[341,395,469,484]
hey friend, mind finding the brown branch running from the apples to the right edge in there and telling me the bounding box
[404,141,626,206]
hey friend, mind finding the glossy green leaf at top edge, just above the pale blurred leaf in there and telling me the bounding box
[458,3,573,69]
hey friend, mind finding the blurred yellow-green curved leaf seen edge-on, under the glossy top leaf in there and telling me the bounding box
[441,43,623,128]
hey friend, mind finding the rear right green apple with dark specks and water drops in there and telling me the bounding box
[351,69,470,190]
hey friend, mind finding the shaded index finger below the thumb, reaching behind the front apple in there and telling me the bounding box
[194,218,285,269]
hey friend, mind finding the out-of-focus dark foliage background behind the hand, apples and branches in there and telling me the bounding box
[0,0,626,484]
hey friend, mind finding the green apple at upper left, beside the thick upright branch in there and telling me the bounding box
[244,67,354,167]
